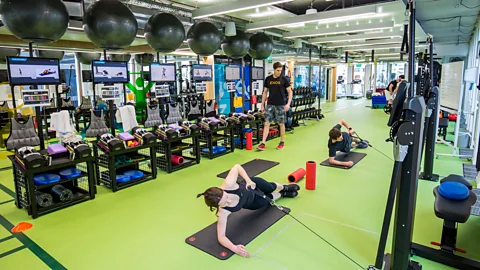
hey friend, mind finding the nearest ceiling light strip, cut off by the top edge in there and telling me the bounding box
[192,0,293,19]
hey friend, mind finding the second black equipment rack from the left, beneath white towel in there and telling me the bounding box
[93,142,157,192]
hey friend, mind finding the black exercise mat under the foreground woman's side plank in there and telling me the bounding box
[185,205,290,260]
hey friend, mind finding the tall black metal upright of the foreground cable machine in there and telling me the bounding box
[369,0,426,270]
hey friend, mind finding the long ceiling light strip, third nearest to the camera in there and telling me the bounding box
[283,21,393,38]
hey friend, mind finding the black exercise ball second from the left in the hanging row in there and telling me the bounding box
[83,0,138,50]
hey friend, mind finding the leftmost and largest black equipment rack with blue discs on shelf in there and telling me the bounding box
[8,155,96,219]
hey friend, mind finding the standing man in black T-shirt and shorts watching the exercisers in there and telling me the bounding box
[257,62,293,151]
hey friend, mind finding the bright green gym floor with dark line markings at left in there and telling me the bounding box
[0,100,480,270]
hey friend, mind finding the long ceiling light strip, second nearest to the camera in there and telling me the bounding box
[248,5,377,31]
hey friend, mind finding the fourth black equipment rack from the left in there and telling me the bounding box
[199,125,235,159]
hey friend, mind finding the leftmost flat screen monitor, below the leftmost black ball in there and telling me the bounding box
[7,57,60,86]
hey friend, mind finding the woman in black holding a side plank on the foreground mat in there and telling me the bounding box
[197,164,300,257]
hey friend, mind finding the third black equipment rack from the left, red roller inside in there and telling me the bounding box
[155,133,200,173]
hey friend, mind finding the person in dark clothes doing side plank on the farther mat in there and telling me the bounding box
[328,120,368,167]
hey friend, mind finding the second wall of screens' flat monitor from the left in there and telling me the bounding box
[92,60,128,83]
